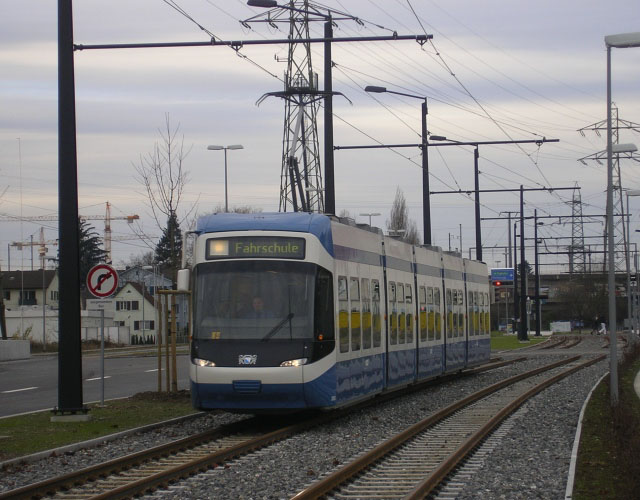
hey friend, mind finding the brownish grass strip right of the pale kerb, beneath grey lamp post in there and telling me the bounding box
[573,347,640,500]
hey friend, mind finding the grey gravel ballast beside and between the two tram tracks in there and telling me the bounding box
[0,346,608,499]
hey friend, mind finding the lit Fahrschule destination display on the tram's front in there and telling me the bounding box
[206,236,305,260]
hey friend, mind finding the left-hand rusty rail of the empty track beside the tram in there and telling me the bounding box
[292,356,600,500]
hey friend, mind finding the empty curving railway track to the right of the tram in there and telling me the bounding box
[294,356,604,500]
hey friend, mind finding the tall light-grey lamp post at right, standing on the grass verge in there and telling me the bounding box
[604,32,640,406]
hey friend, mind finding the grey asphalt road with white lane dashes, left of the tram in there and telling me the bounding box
[0,354,189,417]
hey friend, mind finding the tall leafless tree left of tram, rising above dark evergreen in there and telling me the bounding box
[134,113,197,278]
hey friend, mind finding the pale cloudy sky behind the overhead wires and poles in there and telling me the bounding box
[0,0,640,272]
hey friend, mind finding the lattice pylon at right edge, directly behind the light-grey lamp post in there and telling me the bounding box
[578,106,640,272]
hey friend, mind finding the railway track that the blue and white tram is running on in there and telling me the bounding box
[0,358,525,500]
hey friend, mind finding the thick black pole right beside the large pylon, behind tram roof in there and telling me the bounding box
[324,19,336,214]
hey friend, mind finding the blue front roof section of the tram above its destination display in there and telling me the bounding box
[196,212,334,256]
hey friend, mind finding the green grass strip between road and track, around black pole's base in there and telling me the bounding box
[0,391,195,461]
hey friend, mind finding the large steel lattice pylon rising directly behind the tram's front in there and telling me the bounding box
[243,0,359,212]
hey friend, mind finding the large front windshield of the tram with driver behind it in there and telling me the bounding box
[194,260,324,342]
